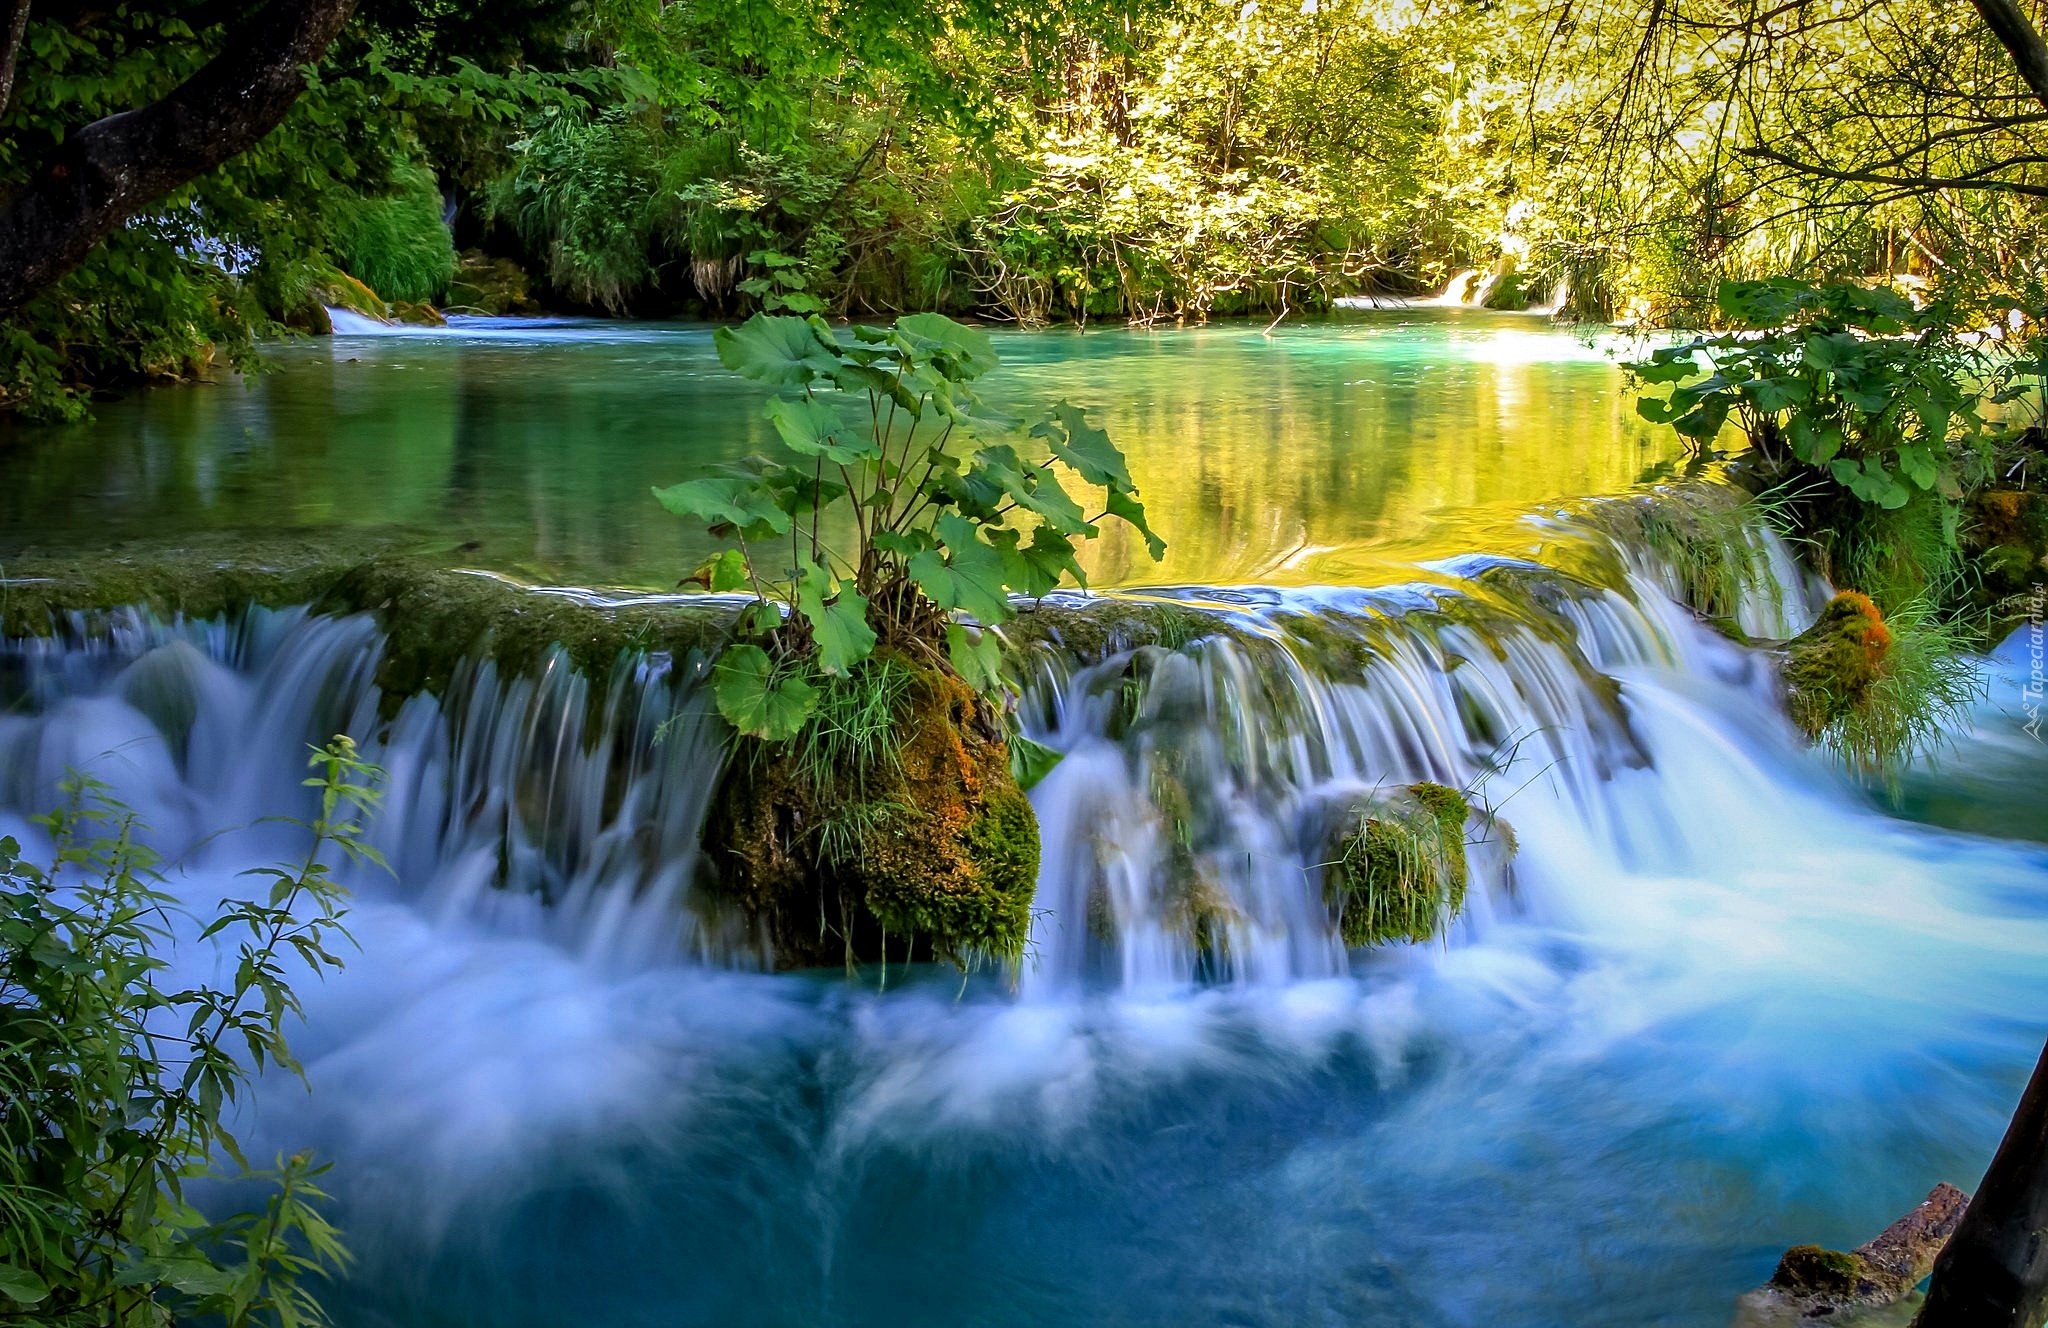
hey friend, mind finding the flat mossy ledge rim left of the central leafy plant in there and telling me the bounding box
[0,539,733,711]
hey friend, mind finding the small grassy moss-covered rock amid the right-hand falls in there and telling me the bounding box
[1323,783,1470,949]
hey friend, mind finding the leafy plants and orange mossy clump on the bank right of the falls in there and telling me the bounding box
[1626,279,2048,777]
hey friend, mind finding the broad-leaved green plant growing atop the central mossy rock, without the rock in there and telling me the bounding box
[655,314,1165,742]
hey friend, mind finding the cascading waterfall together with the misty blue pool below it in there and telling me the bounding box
[0,498,2048,1328]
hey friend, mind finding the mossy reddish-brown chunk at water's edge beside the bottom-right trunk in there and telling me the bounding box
[1735,1185,1970,1328]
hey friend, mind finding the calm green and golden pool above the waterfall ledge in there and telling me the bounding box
[0,309,1671,588]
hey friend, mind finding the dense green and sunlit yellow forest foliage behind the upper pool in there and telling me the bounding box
[0,0,2048,416]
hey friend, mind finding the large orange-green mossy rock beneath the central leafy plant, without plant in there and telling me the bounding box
[705,652,1038,967]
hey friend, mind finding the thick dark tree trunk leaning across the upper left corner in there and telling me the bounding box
[0,0,354,314]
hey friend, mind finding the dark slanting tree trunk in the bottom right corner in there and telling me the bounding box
[1913,1036,2048,1328]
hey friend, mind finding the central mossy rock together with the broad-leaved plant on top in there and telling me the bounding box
[653,315,1165,965]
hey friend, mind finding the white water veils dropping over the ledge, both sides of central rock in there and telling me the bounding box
[0,491,1808,979]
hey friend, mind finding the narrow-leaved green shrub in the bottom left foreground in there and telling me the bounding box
[0,738,375,1328]
